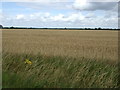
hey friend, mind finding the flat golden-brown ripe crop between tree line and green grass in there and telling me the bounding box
[2,30,118,60]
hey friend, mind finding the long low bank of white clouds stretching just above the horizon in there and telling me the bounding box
[3,12,118,28]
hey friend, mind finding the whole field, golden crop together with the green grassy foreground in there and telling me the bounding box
[2,29,119,88]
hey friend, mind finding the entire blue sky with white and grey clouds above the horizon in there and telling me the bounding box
[0,0,118,28]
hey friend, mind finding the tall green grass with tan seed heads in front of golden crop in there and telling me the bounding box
[3,53,118,88]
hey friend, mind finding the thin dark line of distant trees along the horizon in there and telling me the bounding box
[0,25,119,30]
